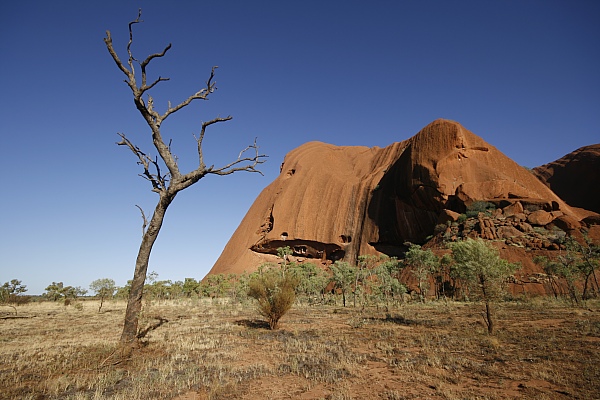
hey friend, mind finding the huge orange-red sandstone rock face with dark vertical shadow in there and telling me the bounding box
[210,120,581,274]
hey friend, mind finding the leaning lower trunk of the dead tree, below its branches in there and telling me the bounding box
[120,196,174,349]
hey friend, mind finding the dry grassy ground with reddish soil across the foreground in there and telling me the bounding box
[0,299,600,400]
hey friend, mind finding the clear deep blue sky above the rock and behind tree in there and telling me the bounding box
[0,0,600,294]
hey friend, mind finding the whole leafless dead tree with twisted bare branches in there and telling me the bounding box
[104,10,266,351]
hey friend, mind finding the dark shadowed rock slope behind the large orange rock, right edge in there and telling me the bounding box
[533,144,600,213]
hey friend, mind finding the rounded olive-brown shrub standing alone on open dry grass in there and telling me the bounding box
[248,265,298,329]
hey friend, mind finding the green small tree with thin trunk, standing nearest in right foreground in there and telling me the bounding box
[449,239,518,335]
